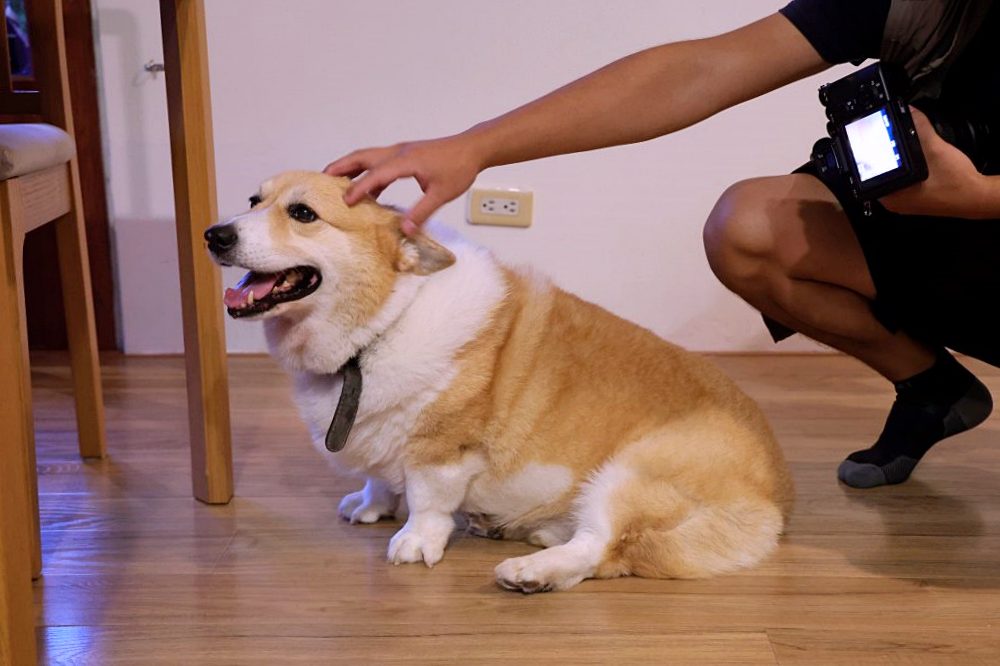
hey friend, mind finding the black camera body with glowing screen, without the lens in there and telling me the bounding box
[812,63,927,201]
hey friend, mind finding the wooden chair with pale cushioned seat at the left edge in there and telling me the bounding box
[0,0,105,666]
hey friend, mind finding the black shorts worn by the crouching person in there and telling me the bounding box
[764,164,1000,366]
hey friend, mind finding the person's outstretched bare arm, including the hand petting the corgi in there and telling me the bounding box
[325,14,829,230]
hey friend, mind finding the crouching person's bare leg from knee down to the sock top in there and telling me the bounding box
[705,175,935,382]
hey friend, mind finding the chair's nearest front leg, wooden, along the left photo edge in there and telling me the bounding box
[0,189,36,664]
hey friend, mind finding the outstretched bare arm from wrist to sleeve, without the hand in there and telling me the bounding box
[458,14,829,168]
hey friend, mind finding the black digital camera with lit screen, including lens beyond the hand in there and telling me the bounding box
[812,63,1000,201]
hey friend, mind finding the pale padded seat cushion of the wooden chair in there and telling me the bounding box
[0,123,76,180]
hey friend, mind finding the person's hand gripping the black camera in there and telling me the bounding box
[879,107,1000,219]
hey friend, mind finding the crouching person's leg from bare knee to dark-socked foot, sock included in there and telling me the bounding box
[705,175,992,487]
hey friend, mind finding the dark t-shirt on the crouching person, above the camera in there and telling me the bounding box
[780,0,1000,117]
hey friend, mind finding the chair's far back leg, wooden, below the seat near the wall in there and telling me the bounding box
[55,165,107,458]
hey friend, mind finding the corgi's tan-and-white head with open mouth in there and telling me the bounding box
[205,171,455,323]
